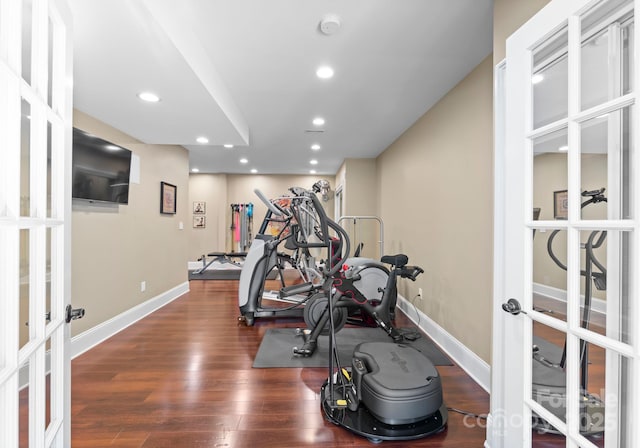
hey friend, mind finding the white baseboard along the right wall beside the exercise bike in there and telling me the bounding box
[398,295,491,393]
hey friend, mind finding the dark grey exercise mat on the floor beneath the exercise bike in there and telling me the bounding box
[253,327,452,368]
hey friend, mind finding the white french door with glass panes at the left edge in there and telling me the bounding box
[0,0,72,448]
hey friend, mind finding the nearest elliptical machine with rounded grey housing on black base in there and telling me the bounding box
[302,189,448,443]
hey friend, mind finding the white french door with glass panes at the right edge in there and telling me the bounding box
[487,0,640,448]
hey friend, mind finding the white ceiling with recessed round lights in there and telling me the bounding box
[69,0,493,174]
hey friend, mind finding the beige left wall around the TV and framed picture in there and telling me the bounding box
[71,111,190,334]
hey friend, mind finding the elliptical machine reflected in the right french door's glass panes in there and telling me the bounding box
[532,188,607,435]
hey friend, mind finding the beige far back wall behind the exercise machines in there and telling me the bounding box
[189,174,334,261]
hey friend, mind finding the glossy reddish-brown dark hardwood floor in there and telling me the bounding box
[25,280,489,448]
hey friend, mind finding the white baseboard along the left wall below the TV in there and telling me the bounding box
[18,282,189,389]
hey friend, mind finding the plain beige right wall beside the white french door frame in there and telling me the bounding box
[376,57,493,362]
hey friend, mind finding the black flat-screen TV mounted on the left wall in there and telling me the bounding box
[72,129,131,204]
